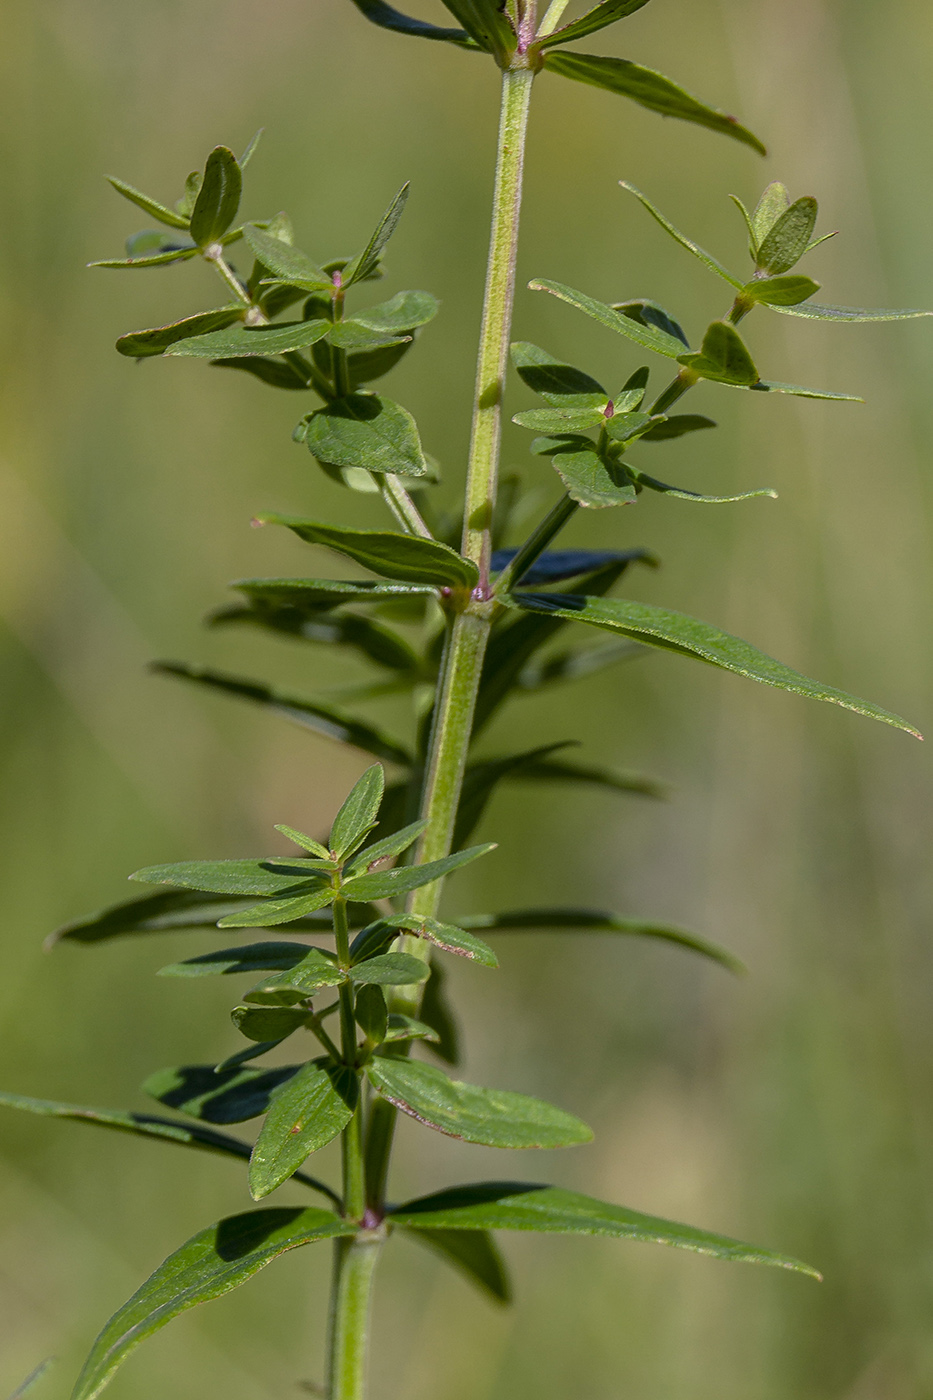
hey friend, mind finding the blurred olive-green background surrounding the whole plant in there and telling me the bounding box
[0,0,933,1400]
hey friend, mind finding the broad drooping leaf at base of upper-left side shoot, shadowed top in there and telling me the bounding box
[304,393,430,476]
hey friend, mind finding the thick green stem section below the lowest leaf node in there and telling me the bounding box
[326,1229,384,1400]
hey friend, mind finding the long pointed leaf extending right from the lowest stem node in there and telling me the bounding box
[391,1182,820,1278]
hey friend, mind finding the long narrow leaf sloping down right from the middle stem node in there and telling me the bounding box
[502,594,920,738]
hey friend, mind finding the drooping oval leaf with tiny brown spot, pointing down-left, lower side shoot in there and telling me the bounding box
[249,1060,359,1201]
